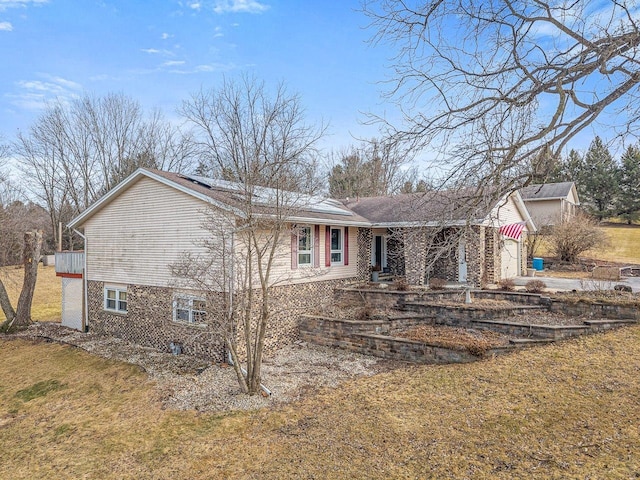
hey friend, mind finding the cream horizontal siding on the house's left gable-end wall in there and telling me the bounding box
[85,178,219,287]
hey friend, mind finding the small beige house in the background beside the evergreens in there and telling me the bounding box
[520,182,580,227]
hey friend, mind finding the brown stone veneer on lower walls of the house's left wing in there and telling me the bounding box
[87,278,356,362]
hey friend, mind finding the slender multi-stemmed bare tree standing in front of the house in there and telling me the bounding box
[172,76,323,394]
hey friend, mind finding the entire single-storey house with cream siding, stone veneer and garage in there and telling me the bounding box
[61,169,535,361]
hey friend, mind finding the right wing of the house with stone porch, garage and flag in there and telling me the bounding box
[345,190,536,285]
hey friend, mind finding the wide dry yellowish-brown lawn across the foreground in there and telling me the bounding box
[0,326,640,479]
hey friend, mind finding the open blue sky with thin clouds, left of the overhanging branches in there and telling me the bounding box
[0,0,396,149]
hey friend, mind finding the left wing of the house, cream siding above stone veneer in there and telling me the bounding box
[65,169,369,361]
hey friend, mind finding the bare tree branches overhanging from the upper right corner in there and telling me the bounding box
[363,0,640,191]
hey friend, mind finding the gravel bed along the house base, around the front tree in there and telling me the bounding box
[5,322,406,412]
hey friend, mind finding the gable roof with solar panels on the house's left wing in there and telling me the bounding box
[69,168,370,228]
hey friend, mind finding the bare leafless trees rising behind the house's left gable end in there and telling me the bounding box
[14,94,192,249]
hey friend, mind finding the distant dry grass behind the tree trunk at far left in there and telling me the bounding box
[0,264,62,322]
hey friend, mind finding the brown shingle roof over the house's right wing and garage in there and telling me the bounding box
[344,188,536,231]
